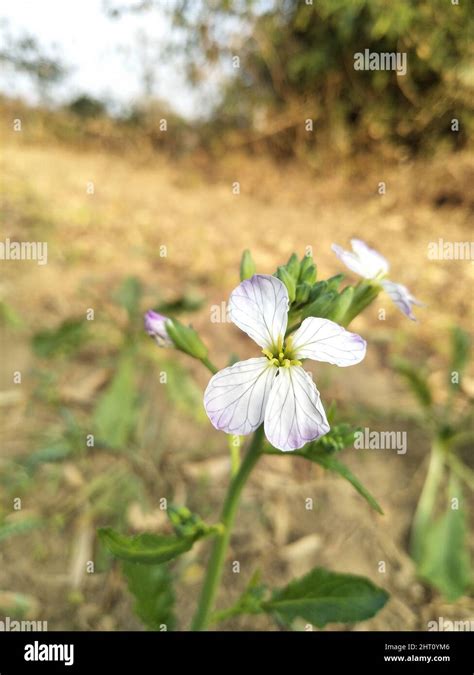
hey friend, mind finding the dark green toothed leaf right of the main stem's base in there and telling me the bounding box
[262,567,389,628]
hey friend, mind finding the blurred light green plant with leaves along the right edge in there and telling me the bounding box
[395,326,474,601]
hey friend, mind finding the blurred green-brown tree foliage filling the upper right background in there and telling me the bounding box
[174,0,474,156]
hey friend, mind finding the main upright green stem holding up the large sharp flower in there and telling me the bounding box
[191,425,263,631]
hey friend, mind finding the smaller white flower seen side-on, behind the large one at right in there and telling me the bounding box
[332,239,424,321]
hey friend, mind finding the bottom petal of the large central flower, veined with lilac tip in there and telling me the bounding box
[264,366,330,451]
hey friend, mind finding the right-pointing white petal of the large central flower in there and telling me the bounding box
[292,316,367,366]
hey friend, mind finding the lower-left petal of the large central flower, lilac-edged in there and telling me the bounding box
[204,357,278,436]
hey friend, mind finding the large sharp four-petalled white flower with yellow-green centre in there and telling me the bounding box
[204,274,366,450]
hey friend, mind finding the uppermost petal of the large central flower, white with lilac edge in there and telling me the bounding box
[229,274,289,348]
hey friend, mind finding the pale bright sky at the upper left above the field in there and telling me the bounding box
[0,0,209,117]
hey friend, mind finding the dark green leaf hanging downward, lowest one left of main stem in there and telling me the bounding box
[122,562,176,630]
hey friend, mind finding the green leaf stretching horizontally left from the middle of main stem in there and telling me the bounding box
[99,527,199,565]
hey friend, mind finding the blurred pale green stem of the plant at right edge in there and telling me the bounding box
[411,438,446,562]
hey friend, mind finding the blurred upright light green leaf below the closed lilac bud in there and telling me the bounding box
[93,356,137,449]
